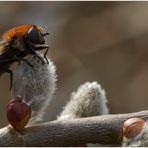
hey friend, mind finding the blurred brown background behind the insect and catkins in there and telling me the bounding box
[0,1,148,127]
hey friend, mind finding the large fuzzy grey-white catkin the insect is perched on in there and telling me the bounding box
[12,53,56,123]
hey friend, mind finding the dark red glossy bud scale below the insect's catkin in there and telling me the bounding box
[6,96,31,131]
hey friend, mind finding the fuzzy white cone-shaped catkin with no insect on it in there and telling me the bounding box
[57,82,108,120]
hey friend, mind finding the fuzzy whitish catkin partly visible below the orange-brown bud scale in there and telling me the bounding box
[122,121,148,147]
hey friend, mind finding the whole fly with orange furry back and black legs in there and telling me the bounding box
[0,24,48,89]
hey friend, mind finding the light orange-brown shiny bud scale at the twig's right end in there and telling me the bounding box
[123,117,145,138]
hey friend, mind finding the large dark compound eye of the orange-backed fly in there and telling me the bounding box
[26,26,45,44]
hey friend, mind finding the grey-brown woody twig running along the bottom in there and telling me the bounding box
[0,111,148,146]
